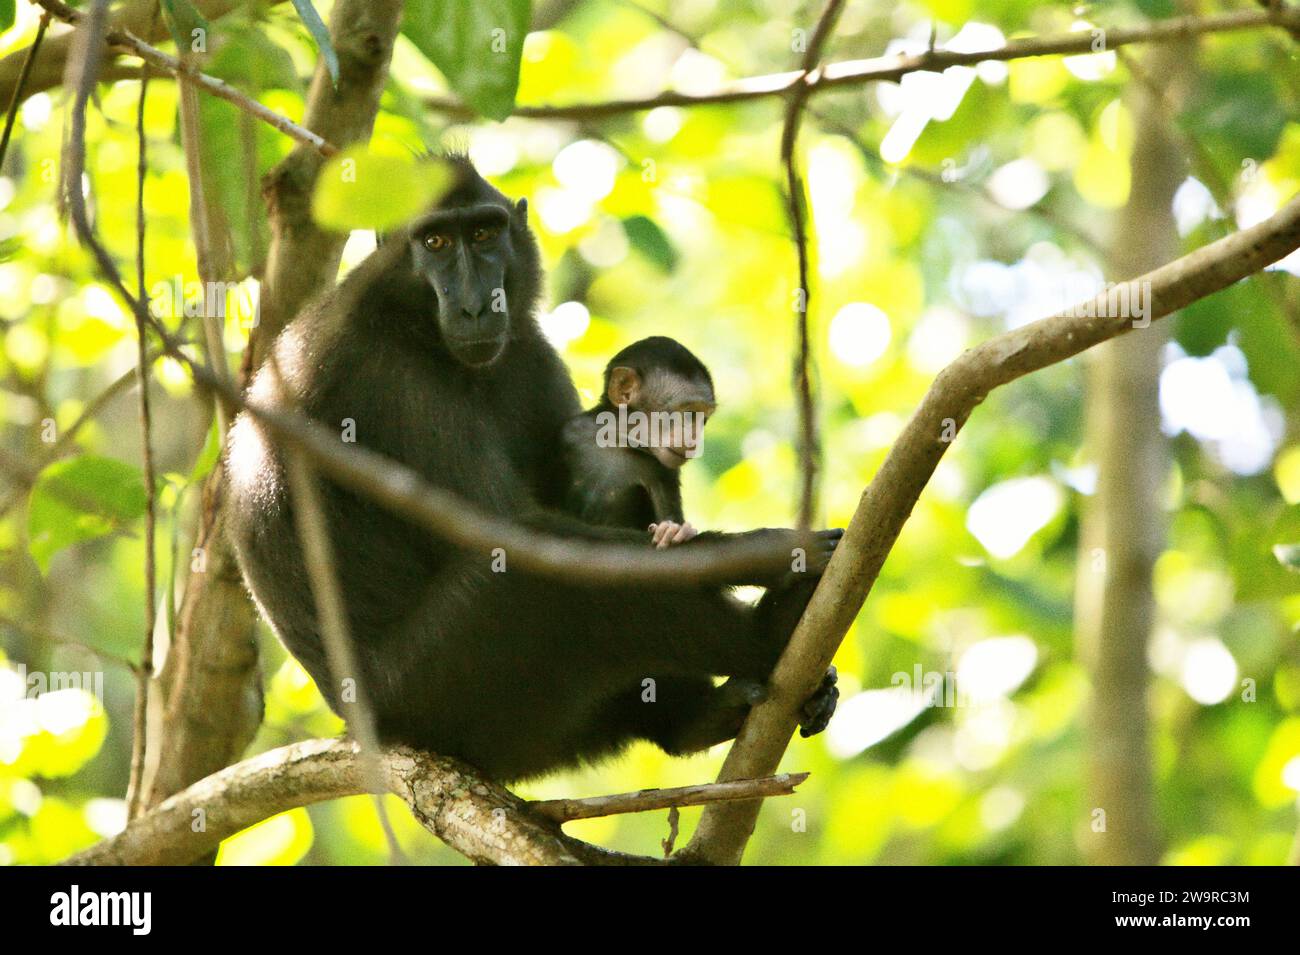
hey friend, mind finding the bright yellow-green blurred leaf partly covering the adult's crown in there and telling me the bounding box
[312,144,451,233]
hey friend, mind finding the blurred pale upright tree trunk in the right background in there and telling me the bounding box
[1075,44,1193,865]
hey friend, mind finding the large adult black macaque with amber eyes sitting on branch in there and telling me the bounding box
[225,157,839,781]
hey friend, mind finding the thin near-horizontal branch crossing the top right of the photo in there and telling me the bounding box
[425,6,1300,121]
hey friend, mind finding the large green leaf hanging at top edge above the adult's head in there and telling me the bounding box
[402,0,532,120]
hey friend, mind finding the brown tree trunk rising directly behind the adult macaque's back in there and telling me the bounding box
[144,0,402,804]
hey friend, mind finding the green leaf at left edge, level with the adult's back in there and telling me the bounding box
[27,455,146,573]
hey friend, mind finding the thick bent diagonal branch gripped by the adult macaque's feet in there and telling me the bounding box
[683,178,1300,864]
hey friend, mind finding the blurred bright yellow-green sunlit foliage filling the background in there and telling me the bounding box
[0,0,1300,864]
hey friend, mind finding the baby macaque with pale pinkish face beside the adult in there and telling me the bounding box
[563,335,718,547]
